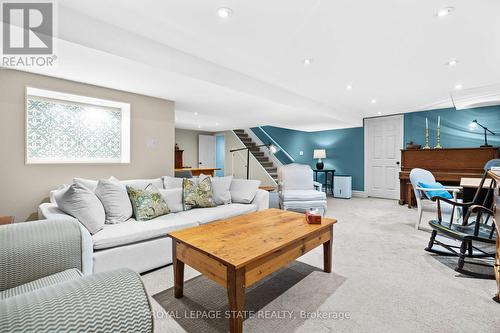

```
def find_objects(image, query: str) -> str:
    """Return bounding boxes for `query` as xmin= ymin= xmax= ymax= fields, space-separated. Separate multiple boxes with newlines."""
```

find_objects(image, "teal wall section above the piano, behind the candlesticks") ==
xmin=404 ymin=106 xmax=500 ymax=148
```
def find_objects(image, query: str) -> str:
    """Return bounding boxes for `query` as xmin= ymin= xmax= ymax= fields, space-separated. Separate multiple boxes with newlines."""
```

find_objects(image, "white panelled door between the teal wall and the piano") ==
xmin=364 ymin=115 xmax=403 ymax=199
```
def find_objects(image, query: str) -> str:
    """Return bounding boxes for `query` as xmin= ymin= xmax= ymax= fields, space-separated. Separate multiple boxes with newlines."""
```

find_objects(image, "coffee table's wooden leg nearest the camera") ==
xmin=227 ymin=267 xmax=245 ymax=333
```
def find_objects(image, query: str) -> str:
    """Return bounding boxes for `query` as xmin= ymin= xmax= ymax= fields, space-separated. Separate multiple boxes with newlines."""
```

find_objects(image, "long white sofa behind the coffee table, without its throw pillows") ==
xmin=38 ymin=178 xmax=269 ymax=274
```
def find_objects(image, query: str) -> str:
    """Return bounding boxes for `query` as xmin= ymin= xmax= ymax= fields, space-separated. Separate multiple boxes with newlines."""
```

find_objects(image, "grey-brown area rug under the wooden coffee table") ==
xmin=153 ymin=261 xmax=345 ymax=333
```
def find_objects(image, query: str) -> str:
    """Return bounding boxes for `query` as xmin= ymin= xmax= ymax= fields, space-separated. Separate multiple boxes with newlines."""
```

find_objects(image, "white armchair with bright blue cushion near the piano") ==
xmin=410 ymin=168 xmax=462 ymax=229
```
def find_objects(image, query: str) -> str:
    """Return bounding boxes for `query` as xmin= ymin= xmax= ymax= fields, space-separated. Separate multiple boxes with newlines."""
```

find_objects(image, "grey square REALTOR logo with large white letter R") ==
xmin=2 ymin=1 xmax=56 ymax=66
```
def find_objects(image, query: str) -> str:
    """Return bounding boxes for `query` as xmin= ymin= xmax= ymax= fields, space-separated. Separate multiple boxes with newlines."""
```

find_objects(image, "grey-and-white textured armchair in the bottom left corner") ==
xmin=0 ymin=220 xmax=153 ymax=333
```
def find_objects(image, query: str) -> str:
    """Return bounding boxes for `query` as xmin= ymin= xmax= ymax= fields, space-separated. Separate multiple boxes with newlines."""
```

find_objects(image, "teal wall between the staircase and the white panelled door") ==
xmin=252 ymin=126 xmax=365 ymax=191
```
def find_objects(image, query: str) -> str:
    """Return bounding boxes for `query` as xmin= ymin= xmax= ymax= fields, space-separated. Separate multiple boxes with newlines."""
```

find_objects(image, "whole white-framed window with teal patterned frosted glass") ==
xmin=26 ymin=87 xmax=130 ymax=164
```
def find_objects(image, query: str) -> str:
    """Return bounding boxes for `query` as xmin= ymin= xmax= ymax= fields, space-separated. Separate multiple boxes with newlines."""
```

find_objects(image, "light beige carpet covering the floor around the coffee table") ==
xmin=143 ymin=198 xmax=500 ymax=332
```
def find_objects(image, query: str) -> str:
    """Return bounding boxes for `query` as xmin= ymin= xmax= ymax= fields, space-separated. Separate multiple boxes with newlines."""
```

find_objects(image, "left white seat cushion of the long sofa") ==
xmin=92 ymin=214 xmax=198 ymax=249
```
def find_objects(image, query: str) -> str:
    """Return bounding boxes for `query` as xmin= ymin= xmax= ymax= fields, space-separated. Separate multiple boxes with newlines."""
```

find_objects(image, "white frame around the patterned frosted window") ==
xmin=24 ymin=87 xmax=130 ymax=164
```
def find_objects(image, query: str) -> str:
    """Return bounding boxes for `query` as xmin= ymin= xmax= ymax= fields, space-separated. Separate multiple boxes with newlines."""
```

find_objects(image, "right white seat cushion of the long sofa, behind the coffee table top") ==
xmin=175 ymin=203 xmax=257 ymax=224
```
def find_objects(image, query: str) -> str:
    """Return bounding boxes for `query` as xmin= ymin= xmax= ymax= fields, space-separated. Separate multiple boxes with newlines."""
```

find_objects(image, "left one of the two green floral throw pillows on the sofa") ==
xmin=127 ymin=184 xmax=170 ymax=221
